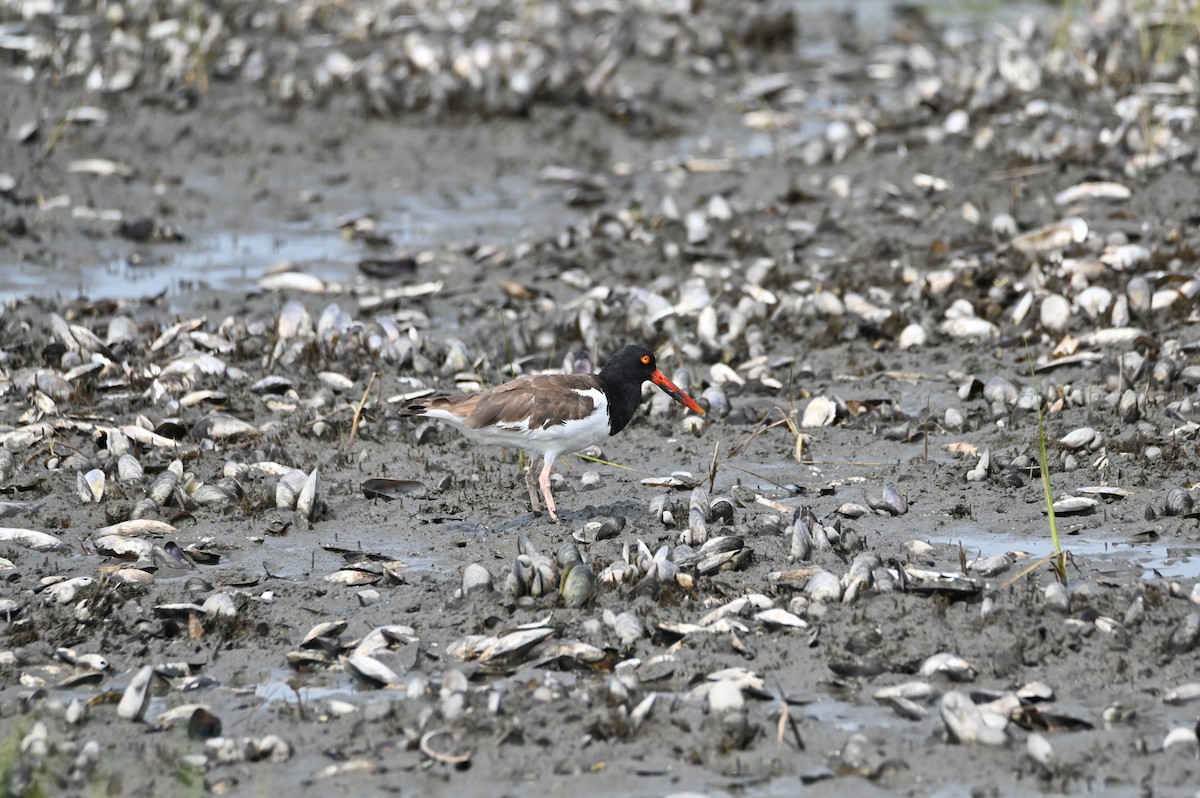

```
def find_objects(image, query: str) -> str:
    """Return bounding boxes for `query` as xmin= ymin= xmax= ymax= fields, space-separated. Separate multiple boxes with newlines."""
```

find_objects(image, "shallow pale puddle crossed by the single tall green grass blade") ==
xmin=930 ymin=522 xmax=1200 ymax=580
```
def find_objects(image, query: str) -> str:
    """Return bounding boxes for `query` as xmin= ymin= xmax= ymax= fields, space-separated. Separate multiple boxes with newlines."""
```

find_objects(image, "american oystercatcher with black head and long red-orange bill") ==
xmin=401 ymin=347 xmax=704 ymax=523
